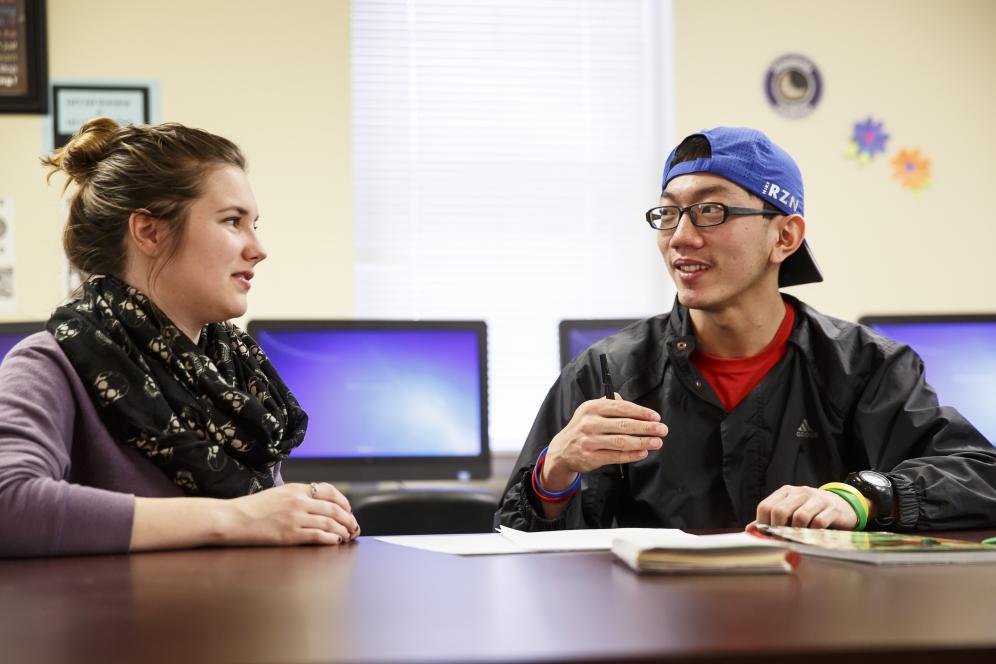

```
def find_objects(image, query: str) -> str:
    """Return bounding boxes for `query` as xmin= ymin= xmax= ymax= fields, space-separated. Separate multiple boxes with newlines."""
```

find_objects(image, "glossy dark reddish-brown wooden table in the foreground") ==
xmin=0 ymin=531 xmax=996 ymax=664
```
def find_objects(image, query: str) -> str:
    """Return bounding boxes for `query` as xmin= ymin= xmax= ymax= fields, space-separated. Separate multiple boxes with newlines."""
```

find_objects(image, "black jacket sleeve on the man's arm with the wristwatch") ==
xmin=854 ymin=346 xmax=996 ymax=530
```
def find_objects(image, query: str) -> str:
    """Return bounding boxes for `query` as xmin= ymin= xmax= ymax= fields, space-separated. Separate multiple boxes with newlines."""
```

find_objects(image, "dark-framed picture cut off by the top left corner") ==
xmin=0 ymin=0 xmax=48 ymax=114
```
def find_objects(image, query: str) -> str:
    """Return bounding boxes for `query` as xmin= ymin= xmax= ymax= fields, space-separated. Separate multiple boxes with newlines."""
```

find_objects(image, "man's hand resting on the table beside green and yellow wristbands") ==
xmin=755 ymin=486 xmax=858 ymax=530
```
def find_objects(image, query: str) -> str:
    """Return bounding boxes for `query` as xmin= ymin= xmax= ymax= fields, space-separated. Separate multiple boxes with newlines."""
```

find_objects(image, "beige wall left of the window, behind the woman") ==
xmin=0 ymin=0 xmax=353 ymax=319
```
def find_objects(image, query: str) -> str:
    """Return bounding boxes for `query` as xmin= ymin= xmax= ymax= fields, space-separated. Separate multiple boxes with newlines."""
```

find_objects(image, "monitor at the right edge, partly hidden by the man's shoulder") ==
xmin=858 ymin=314 xmax=996 ymax=444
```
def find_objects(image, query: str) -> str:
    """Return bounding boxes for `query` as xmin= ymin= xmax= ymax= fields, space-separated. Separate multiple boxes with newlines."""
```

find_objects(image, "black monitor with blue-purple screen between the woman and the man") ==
xmin=248 ymin=320 xmax=491 ymax=482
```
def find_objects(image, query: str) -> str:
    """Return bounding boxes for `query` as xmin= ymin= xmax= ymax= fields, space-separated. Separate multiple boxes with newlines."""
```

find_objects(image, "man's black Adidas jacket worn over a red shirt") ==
xmin=498 ymin=295 xmax=996 ymax=530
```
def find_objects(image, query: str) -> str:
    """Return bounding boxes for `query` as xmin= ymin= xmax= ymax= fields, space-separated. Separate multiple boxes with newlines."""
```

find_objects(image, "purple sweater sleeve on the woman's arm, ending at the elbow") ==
xmin=0 ymin=332 xmax=135 ymax=557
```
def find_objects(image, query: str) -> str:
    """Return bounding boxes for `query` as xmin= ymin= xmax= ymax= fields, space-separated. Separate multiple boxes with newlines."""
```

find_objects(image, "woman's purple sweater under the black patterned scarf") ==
xmin=0 ymin=332 xmax=280 ymax=557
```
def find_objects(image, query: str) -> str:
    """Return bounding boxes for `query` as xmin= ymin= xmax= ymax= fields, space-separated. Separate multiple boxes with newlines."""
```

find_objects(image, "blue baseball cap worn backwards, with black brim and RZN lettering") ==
xmin=661 ymin=127 xmax=823 ymax=287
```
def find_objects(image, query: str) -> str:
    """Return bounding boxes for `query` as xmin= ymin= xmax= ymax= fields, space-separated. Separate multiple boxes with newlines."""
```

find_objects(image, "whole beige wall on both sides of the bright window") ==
xmin=0 ymin=0 xmax=996 ymax=326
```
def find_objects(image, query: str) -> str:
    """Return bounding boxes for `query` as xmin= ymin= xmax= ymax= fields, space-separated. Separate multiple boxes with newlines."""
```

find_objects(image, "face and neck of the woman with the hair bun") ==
xmin=150 ymin=165 xmax=266 ymax=340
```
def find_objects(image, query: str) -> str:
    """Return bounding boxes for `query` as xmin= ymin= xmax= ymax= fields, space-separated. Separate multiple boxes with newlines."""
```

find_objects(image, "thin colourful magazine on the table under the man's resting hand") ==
xmin=757 ymin=525 xmax=996 ymax=565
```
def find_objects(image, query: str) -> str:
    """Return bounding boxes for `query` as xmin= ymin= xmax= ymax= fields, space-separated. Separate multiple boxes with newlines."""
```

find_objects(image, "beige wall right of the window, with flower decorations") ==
xmin=675 ymin=0 xmax=996 ymax=318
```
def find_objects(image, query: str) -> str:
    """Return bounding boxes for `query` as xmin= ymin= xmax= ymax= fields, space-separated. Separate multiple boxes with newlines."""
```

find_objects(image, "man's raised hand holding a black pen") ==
xmin=540 ymin=395 xmax=667 ymax=491
